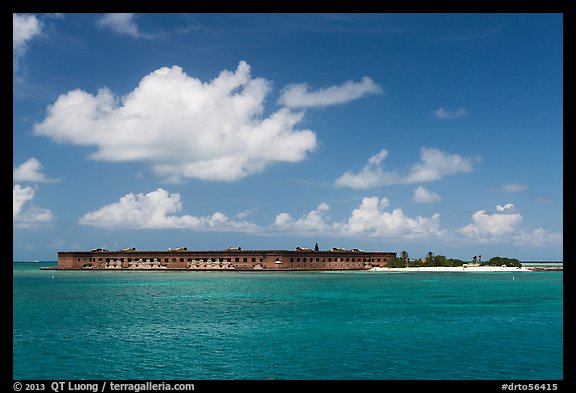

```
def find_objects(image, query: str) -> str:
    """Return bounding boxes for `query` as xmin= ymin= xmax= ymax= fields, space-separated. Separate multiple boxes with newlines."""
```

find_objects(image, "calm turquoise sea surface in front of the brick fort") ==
xmin=13 ymin=263 xmax=563 ymax=380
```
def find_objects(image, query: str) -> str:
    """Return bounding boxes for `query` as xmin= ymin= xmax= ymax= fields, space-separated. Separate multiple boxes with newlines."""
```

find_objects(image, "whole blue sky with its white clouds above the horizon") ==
xmin=13 ymin=13 xmax=563 ymax=261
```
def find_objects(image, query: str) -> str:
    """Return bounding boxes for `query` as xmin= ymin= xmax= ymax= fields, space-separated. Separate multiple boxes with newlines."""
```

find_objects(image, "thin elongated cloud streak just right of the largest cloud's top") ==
xmin=278 ymin=76 xmax=382 ymax=108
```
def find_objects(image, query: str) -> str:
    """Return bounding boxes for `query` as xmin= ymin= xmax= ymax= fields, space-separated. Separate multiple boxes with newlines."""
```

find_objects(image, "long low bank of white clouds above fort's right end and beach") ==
xmin=266 ymin=196 xmax=563 ymax=247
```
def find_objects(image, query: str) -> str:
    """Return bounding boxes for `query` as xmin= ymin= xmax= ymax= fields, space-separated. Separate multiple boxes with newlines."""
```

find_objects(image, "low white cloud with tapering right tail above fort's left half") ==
xmin=78 ymin=188 xmax=258 ymax=232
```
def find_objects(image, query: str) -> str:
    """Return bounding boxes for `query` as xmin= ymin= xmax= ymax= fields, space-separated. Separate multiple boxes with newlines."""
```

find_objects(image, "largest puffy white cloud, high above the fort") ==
xmin=35 ymin=61 xmax=317 ymax=183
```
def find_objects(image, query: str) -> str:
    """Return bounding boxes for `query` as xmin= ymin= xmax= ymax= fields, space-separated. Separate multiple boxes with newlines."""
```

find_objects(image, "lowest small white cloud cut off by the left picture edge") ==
xmin=12 ymin=184 xmax=54 ymax=228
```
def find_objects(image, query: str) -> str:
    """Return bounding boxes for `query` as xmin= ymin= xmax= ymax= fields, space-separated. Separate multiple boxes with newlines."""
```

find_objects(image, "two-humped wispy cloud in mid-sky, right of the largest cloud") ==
xmin=334 ymin=147 xmax=476 ymax=189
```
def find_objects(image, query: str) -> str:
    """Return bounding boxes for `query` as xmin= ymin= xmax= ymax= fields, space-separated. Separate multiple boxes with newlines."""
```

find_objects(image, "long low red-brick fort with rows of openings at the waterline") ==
xmin=58 ymin=247 xmax=396 ymax=271
